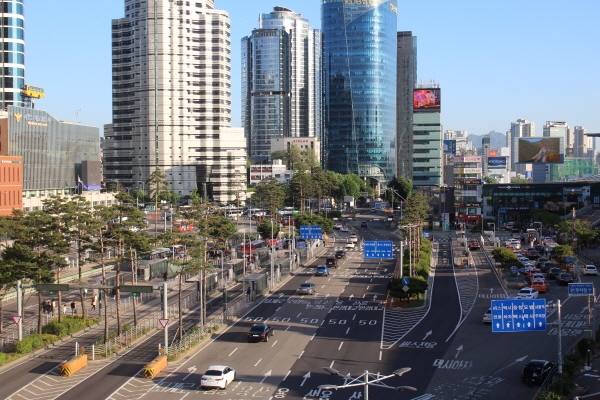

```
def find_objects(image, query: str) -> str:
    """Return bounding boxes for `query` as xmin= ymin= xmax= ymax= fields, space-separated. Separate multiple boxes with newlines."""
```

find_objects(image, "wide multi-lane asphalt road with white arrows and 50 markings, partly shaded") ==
xmin=0 ymin=216 xmax=596 ymax=400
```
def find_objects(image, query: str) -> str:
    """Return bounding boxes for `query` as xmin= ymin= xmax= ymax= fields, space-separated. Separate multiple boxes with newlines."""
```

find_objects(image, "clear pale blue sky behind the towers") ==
xmin=25 ymin=0 xmax=600 ymax=141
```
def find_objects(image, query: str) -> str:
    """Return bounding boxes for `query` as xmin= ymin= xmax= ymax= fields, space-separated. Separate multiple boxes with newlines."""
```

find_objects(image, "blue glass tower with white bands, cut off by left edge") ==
xmin=0 ymin=0 xmax=25 ymax=111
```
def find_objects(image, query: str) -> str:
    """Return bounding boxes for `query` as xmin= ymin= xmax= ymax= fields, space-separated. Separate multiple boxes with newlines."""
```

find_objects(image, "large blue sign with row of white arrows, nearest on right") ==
xmin=492 ymin=299 xmax=546 ymax=332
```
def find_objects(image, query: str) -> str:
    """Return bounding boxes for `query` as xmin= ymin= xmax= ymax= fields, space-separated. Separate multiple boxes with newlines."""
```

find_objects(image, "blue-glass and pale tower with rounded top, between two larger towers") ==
xmin=242 ymin=7 xmax=322 ymax=161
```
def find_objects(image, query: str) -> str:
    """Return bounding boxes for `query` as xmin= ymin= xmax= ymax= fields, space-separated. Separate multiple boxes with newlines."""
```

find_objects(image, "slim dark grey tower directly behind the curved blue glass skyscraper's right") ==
xmin=396 ymin=31 xmax=417 ymax=179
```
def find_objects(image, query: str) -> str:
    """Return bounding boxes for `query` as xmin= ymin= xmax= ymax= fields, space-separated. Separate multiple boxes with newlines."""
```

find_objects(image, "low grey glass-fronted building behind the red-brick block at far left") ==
xmin=0 ymin=106 xmax=100 ymax=198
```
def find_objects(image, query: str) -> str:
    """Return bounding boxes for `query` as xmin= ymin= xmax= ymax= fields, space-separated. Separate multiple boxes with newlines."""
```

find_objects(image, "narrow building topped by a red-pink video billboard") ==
xmin=412 ymin=83 xmax=444 ymax=186
